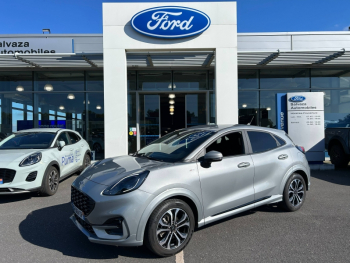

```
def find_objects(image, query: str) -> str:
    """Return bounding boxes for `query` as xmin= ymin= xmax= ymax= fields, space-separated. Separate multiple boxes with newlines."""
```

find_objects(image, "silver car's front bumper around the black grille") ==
xmin=70 ymin=176 xmax=154 ymax=246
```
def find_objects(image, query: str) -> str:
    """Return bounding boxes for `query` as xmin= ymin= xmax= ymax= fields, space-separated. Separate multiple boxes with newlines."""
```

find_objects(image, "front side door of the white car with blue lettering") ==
xmin=56 ymin=132 xmax=74 ymax=177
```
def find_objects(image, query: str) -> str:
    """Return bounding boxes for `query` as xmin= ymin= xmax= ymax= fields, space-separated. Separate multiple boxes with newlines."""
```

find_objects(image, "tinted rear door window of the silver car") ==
xmin=248 ymin=131 xmax=279 ymax=153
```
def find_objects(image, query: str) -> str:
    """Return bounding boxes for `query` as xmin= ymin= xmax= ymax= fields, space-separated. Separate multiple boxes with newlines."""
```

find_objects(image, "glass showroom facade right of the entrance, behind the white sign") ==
xmin=238 ymin=68 xmax=350 ymax=128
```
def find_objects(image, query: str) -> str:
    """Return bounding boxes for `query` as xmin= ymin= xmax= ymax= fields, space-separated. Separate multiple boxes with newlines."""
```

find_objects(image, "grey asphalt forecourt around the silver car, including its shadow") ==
xmin=0 ymin=166 xmax=350 ymax=263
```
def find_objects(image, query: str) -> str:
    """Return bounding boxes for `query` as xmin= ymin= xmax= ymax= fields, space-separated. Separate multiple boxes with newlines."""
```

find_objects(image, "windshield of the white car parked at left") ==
xmin=0 ymin=132 xmax=56 ymax=150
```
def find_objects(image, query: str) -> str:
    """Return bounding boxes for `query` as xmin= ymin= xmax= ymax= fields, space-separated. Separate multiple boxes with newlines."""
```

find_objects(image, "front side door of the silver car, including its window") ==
xmin=197 ymin=132 xmax=254 ymax=218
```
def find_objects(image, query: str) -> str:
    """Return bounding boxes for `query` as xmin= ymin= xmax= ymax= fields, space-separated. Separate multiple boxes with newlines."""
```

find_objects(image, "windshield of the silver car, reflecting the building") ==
xmin=136 ymin=130 xmax=214 ymax=162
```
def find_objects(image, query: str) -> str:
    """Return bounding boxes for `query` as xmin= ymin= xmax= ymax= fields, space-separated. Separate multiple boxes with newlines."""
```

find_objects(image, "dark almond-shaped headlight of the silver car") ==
xmin=103 ymin=171 xmax=149 ymax=195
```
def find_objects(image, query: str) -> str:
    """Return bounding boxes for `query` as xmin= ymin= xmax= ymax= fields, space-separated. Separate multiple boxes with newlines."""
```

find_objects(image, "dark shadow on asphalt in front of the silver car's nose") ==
xmin=19 ymin=203 xmax=155 ymax=259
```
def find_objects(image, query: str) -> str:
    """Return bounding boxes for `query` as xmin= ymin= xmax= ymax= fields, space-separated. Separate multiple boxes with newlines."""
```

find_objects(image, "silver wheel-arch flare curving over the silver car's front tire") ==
xmin=136 ymin=188 xmax=204 ymax=241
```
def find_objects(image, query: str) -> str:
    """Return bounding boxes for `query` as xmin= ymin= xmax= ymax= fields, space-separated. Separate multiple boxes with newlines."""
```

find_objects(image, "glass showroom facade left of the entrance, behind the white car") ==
xmin=0 ymin=71 xmax=104 ymax=159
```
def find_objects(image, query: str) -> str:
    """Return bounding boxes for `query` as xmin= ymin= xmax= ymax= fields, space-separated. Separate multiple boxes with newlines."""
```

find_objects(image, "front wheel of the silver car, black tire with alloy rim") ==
xmin=144 ymin=199 xmax=195 ymax=257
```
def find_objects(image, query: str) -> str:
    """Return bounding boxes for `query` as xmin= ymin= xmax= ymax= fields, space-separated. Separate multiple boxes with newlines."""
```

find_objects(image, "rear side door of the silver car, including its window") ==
xmin=247 ymin=131 xmax=293 ymax=200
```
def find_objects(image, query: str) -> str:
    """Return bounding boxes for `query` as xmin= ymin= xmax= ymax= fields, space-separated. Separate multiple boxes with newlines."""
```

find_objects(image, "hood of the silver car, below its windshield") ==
xmin=80 ymin=155 xmax=171 ymax=186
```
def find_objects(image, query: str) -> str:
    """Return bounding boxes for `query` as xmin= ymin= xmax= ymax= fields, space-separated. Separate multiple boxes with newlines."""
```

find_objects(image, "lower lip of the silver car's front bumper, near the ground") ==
xmin=70 ymin=214 xmax=143 ymax=247
